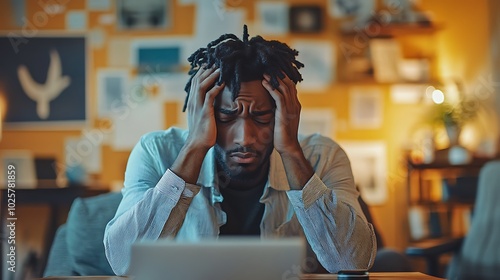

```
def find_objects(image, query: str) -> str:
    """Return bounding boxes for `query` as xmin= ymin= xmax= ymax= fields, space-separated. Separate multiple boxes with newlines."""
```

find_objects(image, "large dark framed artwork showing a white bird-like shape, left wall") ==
xmin=0 ymin=35 xmax=87 ymax=128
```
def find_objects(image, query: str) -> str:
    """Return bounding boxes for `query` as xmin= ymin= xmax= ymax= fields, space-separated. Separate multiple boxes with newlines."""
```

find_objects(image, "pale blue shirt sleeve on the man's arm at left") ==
xmin=103 ymin=135 xmax=199 ymax=275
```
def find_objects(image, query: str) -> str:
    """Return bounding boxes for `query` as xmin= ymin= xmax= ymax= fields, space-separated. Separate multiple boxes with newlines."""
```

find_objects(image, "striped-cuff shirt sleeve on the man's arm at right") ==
xmin=287 ymin=144 xmax=377 ymax=273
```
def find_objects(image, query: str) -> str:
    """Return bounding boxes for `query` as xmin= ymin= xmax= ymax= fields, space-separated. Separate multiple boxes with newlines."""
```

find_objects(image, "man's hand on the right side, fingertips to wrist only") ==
xmin=262 ymin=75 xmax=301 ymax=154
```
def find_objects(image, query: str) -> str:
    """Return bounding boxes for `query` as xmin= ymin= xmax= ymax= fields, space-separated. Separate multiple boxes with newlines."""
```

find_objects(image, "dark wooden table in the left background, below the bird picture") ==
xmin=0 ymin=186 xmax=108 ymax=276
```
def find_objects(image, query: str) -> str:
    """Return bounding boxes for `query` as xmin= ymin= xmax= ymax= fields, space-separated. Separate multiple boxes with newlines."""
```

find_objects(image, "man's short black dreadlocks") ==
xmin=182 ymin=25 xmax=304 ymax=111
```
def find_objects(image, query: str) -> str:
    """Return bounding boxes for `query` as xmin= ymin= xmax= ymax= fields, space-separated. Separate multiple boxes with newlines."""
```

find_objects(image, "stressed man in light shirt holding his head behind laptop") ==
xmin=104 ymin=26 xmax=376 ymax=275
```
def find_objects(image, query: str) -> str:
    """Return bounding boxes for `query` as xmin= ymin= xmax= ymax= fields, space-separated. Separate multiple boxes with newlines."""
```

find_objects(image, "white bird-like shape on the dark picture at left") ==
xmin=17 ymin=50 xmax=71 ymax=119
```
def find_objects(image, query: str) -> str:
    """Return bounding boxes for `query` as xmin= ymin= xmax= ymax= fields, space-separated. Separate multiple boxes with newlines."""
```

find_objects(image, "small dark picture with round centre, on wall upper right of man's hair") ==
xmin=289 ymin=6 xmax=323 ymax=33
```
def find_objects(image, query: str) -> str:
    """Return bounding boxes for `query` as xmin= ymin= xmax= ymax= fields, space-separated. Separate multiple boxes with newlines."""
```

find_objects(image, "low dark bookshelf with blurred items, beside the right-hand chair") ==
xmin=407 ymin=154 xmax=491 ymax=243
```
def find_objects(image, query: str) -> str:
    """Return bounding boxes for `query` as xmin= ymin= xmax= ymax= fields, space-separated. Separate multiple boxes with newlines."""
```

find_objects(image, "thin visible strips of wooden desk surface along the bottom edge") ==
xmin=43 ymin=272 xmax=442 ymax=280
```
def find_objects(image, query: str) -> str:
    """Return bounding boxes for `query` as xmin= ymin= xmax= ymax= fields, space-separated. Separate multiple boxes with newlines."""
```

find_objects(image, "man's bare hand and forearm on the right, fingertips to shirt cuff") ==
xmin=262 ymin=75 xmax=314 ymax=190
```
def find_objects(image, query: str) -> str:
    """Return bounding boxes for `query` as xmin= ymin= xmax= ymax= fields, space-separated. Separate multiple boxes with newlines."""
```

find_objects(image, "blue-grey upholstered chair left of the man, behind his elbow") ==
xmin=43 ymin=193 xmax=122 ymax=277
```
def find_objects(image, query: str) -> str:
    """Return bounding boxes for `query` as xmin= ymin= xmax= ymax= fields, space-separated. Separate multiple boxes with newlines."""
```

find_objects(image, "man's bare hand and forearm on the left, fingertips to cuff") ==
xmin=170 ymin=67 xmax=224 ymax=184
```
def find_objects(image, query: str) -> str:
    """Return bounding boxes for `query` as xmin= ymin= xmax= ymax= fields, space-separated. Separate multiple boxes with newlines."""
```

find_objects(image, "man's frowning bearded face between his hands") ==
xmin=215 ymin=80 xmax=275 ymax=181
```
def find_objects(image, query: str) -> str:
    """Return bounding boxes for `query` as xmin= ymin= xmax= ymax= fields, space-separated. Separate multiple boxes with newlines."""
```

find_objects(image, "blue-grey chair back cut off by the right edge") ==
xmin=447 ymin=160 xmax=500 ymax=279
